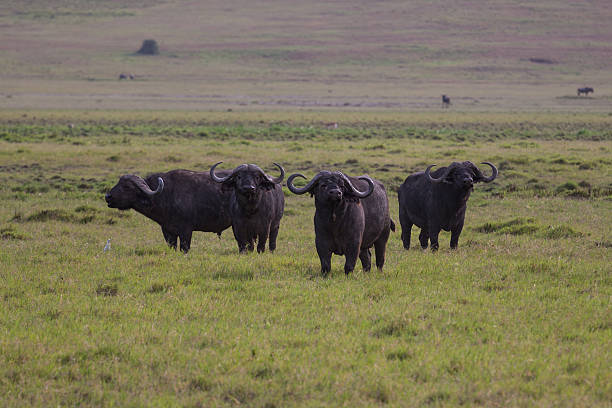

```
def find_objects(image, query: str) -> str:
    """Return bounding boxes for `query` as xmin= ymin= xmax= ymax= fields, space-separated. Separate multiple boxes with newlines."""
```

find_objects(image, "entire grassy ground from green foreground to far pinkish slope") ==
xmin=0 ymin=0 xmax=612 ymax=408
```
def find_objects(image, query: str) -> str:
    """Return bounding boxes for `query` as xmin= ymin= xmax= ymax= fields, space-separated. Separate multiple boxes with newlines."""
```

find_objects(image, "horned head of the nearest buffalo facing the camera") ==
xmin=287 ymin=170 xmax=374 ymax=203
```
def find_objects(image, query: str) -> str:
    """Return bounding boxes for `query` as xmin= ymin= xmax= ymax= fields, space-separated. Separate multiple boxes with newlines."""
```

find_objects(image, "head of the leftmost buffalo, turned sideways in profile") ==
xmin=104 ymin=174 xmax=164 ymax=210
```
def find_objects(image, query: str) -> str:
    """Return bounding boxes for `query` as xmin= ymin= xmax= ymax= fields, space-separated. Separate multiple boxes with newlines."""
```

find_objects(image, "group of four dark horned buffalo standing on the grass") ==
xmin=105 ymin=161 xmax=498 ymax=275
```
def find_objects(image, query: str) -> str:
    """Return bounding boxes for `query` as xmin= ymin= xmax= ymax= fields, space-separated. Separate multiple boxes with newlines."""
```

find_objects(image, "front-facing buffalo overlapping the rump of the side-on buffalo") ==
xmin=210 ymin=162 xmax=285 ymax=253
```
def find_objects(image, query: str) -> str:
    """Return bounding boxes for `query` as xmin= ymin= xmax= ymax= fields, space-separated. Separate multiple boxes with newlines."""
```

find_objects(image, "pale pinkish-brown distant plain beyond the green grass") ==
xmin=0 ymin=0 xmax=612 ymax=112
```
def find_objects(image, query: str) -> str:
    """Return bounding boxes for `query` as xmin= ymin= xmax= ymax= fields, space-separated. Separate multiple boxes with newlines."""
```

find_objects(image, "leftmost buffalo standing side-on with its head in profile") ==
xmin=105 ymin=170 xmax=232 ymax=253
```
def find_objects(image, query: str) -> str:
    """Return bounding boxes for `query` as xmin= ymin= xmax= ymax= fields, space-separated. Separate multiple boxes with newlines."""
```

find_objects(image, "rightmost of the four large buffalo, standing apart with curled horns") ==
xmin=398 ymin=161 xmax=498 ymax=251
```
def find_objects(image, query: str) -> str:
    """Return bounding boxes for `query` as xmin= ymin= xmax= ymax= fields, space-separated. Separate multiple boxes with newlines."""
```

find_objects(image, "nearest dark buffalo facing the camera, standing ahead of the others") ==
xmin=287 ymin=171 xmax=395 ymax=275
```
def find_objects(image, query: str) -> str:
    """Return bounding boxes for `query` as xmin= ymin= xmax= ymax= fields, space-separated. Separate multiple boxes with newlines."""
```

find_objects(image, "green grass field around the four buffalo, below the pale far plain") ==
xmin=0 ymin=111 xmax=612 ymax=407
